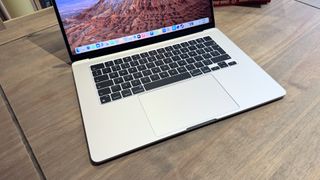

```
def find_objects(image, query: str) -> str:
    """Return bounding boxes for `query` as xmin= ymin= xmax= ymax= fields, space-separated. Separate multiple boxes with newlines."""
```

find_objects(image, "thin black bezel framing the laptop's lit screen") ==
xmin=52 ymin=0 xmax=215 ymax=62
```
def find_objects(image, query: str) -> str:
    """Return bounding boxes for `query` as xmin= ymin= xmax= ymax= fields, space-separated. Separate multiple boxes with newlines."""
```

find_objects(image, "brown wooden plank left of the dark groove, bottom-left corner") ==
xmin=0 ymin=92 xmax=39 ymax=180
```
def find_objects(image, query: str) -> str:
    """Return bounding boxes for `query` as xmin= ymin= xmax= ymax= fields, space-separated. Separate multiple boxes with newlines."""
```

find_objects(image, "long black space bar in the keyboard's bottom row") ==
xmin=144 ymin=72 xmax=191 ymax=91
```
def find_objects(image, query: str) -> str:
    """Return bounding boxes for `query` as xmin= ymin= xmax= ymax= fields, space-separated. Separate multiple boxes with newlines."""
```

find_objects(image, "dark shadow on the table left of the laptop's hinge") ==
xmin=27 ymin=25 xmax=71 ymax=65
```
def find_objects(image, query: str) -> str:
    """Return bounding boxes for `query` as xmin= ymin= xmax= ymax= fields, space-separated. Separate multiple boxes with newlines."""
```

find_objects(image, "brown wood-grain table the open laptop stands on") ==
xmin=0 ymin=0 xmax=320 ymax=180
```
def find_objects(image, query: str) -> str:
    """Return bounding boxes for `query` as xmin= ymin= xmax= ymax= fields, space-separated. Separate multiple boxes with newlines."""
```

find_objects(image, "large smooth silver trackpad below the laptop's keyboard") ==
xmin=139 ymin=75 xmax=239 ymax=136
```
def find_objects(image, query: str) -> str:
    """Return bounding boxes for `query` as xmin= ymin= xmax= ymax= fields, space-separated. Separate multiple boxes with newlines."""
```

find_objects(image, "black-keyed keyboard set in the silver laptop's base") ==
xmin=90 ymin=36 xmax=237 ymax=104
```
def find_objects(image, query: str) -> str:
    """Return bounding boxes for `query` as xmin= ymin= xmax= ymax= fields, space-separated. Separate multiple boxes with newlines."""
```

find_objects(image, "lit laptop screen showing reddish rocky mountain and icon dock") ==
xmin=56 ymin=0 xmax=213 ymax=55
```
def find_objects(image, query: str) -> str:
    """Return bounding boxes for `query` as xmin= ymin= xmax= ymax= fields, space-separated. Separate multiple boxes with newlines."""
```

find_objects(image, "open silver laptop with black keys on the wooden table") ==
xmin=53 ymin=0 xmax=286 ymax=165
